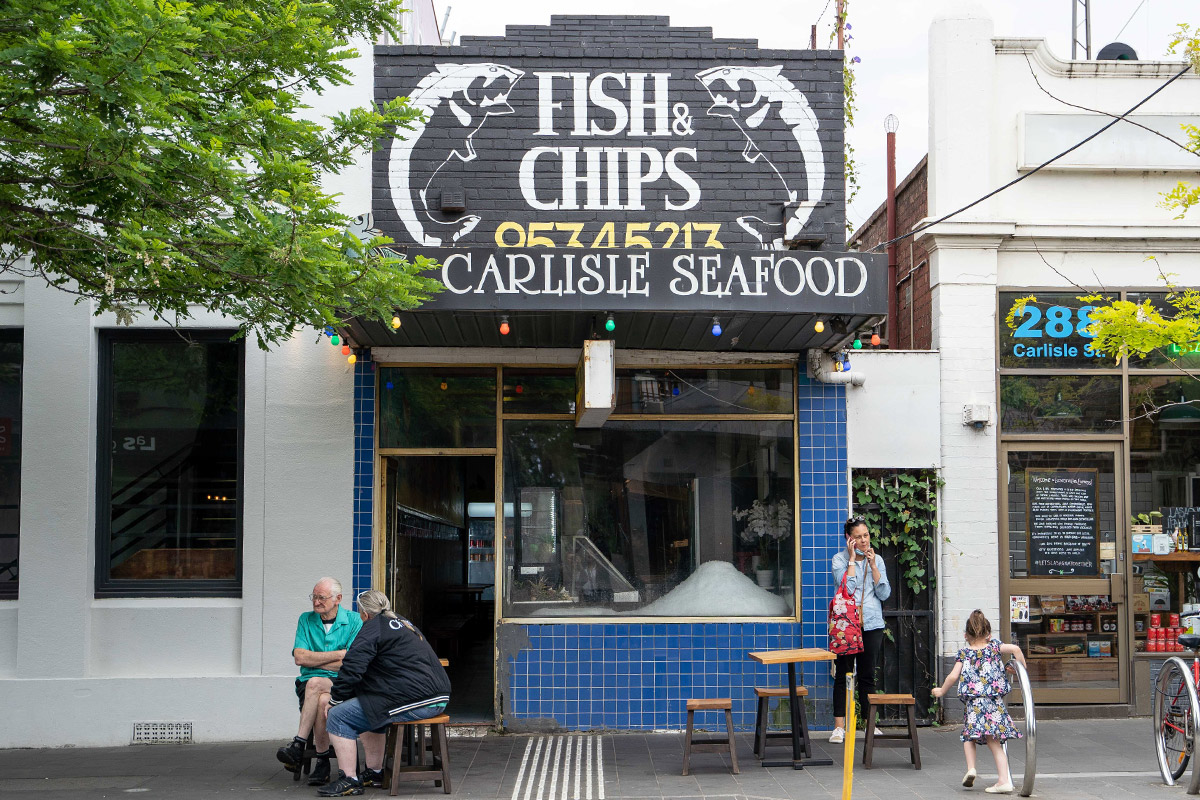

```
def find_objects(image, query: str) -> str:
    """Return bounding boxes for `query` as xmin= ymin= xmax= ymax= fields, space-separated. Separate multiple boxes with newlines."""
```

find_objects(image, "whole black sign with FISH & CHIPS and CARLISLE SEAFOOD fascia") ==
xmin=372 ymin=17 xmax=887 ymax=313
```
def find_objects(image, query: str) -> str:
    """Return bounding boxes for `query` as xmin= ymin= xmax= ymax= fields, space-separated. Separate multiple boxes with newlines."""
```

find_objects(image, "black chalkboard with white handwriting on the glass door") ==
xmin=1025 ymin=469 xmax=1099 ymax=577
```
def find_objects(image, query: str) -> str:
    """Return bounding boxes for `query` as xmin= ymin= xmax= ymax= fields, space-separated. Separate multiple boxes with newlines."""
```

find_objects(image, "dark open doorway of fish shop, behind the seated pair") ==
xmin=378 ymin=455 xmax=496 ymax=724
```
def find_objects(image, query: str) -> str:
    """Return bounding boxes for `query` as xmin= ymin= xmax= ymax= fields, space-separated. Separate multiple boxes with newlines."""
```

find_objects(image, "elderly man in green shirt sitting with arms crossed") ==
xmin=276 ymin=578 xmax=362 ymax=786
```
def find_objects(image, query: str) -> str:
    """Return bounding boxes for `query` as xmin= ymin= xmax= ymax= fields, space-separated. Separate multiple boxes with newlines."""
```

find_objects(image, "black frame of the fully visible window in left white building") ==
xmin=95 ymin=329 xmax=246 ymax=599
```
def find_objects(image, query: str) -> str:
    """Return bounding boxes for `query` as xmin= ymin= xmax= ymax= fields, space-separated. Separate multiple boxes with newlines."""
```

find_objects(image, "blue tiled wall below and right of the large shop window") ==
xmin=500 ymin=376 xmax=850 ymax=730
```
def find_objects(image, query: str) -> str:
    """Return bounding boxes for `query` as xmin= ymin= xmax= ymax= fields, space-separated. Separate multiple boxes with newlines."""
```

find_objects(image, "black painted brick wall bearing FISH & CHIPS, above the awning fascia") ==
xmin=372 ymin=16 xmax=845 ymax=251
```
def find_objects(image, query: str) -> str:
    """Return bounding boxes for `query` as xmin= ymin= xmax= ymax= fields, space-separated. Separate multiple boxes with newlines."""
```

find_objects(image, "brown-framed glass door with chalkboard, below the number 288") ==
xmin=1000 ymin=441 xmax=1132 ymax=703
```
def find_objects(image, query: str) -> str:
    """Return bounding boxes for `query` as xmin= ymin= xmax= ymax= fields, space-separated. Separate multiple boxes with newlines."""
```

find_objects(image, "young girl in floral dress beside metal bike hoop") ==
xmin=934 ymin=608 xmax=1025 ymax=794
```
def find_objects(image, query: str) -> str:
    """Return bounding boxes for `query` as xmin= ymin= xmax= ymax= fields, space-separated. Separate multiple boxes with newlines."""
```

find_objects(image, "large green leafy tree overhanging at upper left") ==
xmin=0 ymin=0 xmax=439 ymax=347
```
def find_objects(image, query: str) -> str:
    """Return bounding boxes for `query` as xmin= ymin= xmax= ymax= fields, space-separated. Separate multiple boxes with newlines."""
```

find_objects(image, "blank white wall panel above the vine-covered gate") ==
xmin=846 ymin=350 xmax=942 ymax=469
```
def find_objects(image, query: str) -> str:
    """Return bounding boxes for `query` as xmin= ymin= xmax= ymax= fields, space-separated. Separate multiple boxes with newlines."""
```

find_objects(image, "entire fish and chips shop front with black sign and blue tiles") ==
xmin=338 ymin=17 xmax=887 ymax=729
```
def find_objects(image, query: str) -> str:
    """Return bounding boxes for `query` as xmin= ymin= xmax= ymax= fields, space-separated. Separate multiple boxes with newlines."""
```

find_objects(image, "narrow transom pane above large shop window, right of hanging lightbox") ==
xmin=614 ymin=368 xmax=793 ymax=415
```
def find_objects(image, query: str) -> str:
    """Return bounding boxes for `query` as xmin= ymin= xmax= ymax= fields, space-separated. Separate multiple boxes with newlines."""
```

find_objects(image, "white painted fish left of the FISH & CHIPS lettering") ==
xmin=390 ymin=61 xmax=524 ymax=247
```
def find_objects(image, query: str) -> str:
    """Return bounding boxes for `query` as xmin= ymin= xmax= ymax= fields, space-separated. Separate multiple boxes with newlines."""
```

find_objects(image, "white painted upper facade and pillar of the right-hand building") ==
xmin=920 ymin=4 xmax=1200 ymax=655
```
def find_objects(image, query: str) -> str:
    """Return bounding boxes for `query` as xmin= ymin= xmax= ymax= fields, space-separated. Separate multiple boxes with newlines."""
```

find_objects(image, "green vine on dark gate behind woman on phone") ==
xmin=853 ymin=470 xmax=943 ymax=594
